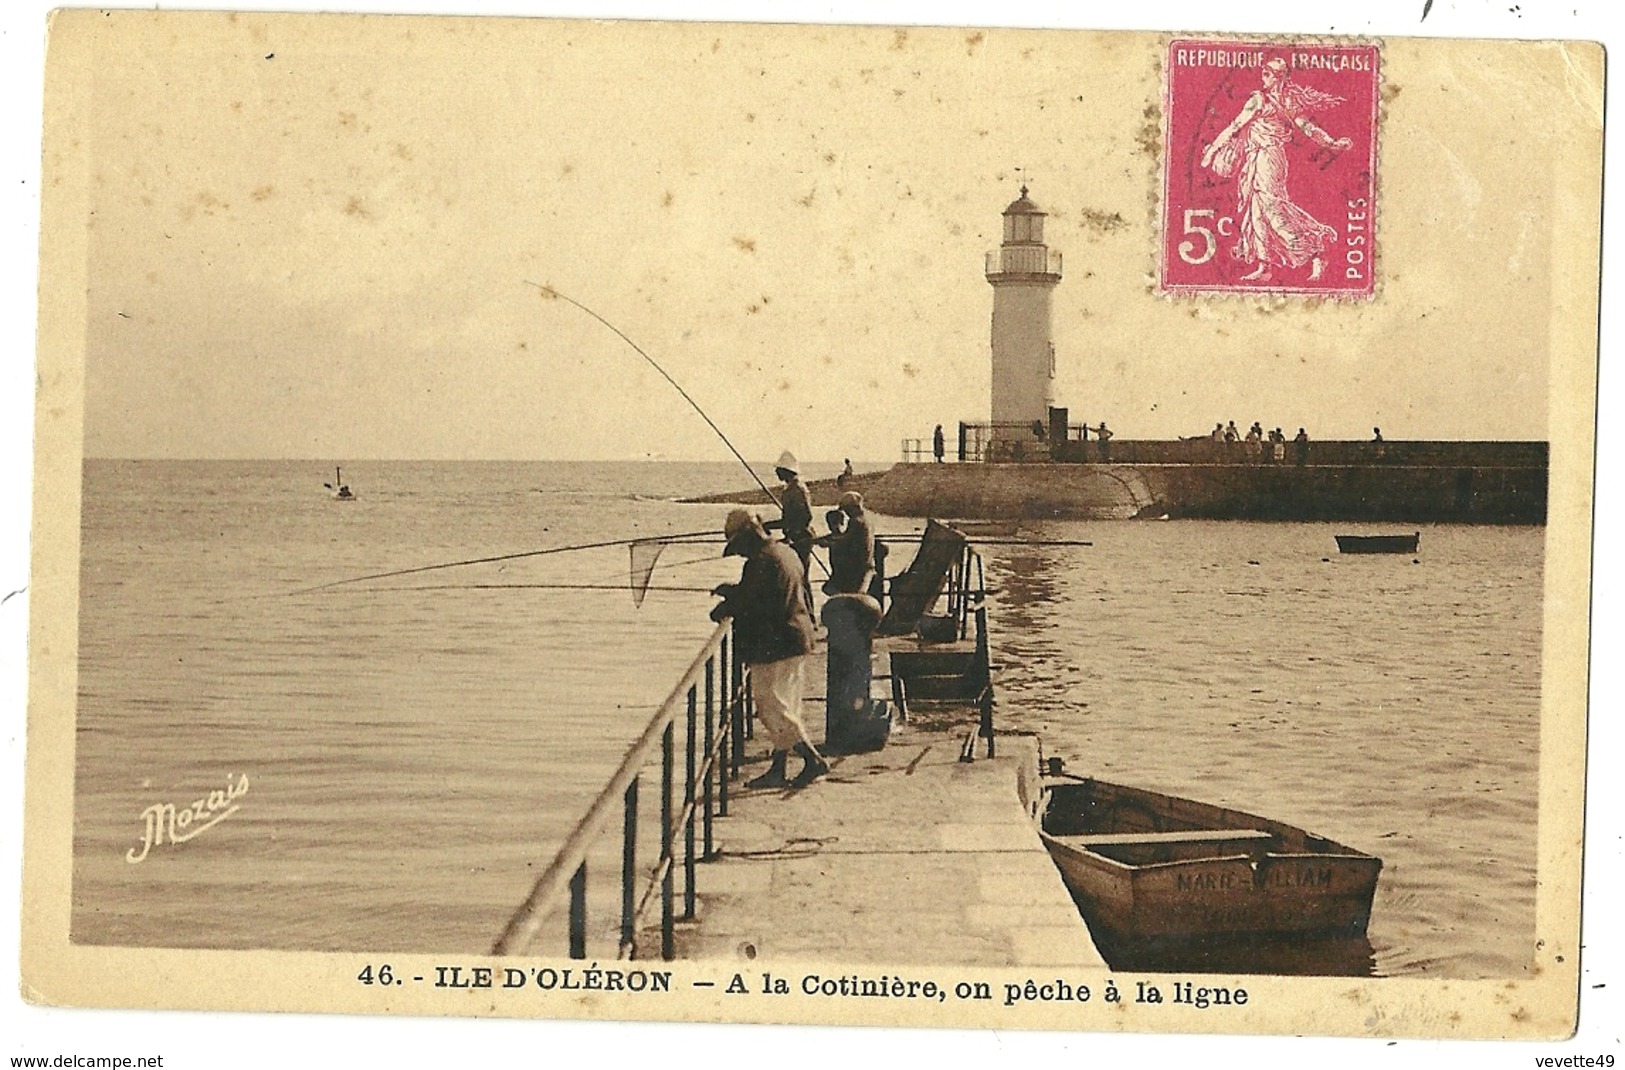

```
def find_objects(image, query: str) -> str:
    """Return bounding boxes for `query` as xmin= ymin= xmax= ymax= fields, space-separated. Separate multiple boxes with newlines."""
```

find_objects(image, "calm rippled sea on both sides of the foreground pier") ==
xmin=73 ymin=460 xmax=1544 ymax=977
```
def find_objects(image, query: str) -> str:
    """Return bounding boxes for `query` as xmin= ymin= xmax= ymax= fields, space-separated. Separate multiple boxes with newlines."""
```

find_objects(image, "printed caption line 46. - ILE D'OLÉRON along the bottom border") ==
xmin=356 ymin=963 xmax=1250 ymax=1010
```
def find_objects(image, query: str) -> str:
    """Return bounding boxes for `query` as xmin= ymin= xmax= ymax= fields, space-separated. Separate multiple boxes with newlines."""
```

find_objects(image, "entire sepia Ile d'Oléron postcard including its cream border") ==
xmin=21 ymin=10 xmax=1604 ymax=1039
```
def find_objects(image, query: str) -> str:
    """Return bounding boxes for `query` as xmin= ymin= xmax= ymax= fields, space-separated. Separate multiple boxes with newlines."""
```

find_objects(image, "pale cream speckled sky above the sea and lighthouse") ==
xmin=69 ymin=1 xmax=1594 ymax=460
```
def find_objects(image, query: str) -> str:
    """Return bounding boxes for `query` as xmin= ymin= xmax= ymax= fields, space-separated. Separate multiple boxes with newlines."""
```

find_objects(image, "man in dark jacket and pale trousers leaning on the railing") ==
xmin=710 ymin=509 xmax=829 ymax=787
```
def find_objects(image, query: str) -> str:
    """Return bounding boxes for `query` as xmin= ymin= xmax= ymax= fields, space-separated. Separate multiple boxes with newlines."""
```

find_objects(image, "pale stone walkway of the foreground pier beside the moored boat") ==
xmin=678 ymin=640 xmax=1103 ymax=968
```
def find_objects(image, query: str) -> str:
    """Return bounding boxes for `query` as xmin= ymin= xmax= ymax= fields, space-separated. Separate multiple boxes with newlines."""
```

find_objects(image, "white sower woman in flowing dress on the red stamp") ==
xmin=1203 ymin=55 xmax=1354 ymax=281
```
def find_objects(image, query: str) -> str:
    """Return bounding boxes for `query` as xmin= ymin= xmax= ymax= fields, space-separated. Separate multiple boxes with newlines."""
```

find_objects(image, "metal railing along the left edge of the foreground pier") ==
xmin=492 ymin=621 xmax=752 ymax=961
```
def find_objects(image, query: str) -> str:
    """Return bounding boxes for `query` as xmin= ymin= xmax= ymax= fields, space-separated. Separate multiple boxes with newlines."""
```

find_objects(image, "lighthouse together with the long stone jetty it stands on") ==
xmin=696 ymin=185 xmax=1547 ymax=524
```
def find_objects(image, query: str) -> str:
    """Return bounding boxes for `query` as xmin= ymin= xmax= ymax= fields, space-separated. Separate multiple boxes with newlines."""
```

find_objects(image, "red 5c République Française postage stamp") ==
xmin=1160 ymin=41 xmax=1378 ymax=298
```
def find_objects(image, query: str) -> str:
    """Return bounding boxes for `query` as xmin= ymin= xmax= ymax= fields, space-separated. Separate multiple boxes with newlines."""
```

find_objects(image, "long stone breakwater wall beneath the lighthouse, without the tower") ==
xmin=685 ymin=441 xmax=1547 ymax=524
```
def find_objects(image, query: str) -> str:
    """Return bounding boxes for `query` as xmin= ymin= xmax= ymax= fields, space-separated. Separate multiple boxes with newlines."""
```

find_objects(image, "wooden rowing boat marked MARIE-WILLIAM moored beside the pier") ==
xmin=1040 ymin=763 xmax=1383 ymax=945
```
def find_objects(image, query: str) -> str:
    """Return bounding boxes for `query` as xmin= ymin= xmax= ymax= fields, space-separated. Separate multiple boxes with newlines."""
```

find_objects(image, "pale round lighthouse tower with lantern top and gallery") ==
xmin=986 ymin=185 xmax=1061 ymax=442
